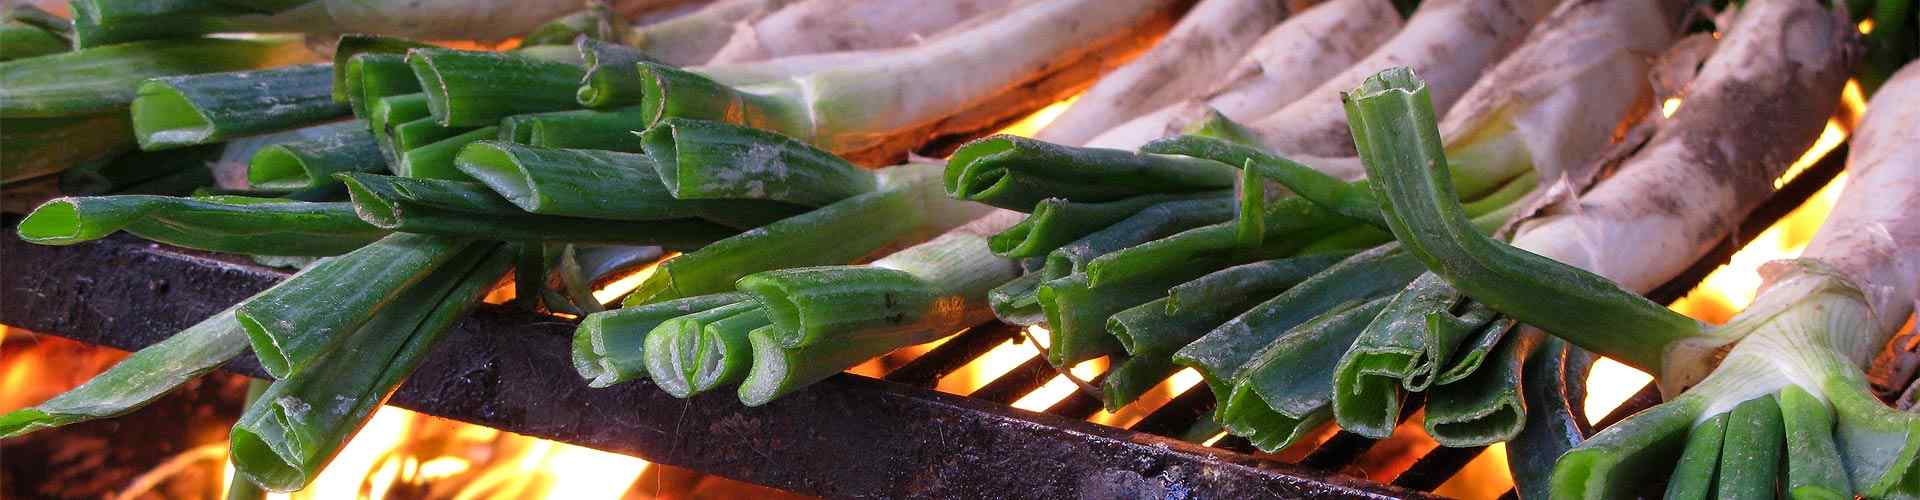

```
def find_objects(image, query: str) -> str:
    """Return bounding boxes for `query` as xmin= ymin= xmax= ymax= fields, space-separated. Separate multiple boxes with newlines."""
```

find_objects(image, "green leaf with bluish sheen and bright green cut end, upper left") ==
xmin=132 ymin=63 xmax=349 ymax=150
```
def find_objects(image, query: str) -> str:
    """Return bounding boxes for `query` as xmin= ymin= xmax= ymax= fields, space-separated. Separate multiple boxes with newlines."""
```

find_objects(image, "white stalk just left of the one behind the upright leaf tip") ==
xmin=1090 ymin=0 xmax=1402 ymax=150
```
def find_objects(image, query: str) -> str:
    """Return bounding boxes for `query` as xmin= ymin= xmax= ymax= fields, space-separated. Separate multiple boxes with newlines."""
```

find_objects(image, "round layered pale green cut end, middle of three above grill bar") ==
xmin=645 ymin=300 xmax=772 ymax=398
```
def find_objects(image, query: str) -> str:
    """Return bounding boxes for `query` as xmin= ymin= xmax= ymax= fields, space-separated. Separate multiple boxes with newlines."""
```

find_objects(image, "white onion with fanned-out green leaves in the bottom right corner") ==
xmin=1553 ymin=59 xmax=1920 ymax=498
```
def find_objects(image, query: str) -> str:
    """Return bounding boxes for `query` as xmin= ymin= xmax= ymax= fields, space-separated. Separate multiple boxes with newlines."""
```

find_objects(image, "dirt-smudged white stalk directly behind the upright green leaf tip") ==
xmin=1248 ymin=0 xmax=1559 ymax=158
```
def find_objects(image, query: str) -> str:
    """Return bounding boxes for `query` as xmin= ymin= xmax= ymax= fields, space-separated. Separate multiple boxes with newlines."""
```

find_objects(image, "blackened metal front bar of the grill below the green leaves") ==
xmin=0 ymin=229 xmax=1421 ymax=498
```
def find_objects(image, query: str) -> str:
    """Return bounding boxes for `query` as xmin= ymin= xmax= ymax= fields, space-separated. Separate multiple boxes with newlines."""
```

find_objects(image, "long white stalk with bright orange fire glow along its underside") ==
xmin=643 ymin=0 xmax=1179 ymax=158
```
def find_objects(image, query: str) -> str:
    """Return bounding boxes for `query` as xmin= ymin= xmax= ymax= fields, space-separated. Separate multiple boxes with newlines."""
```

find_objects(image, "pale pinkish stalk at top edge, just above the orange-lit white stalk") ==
xmin=707 ymin=0 xmax=1014 ymax=65
